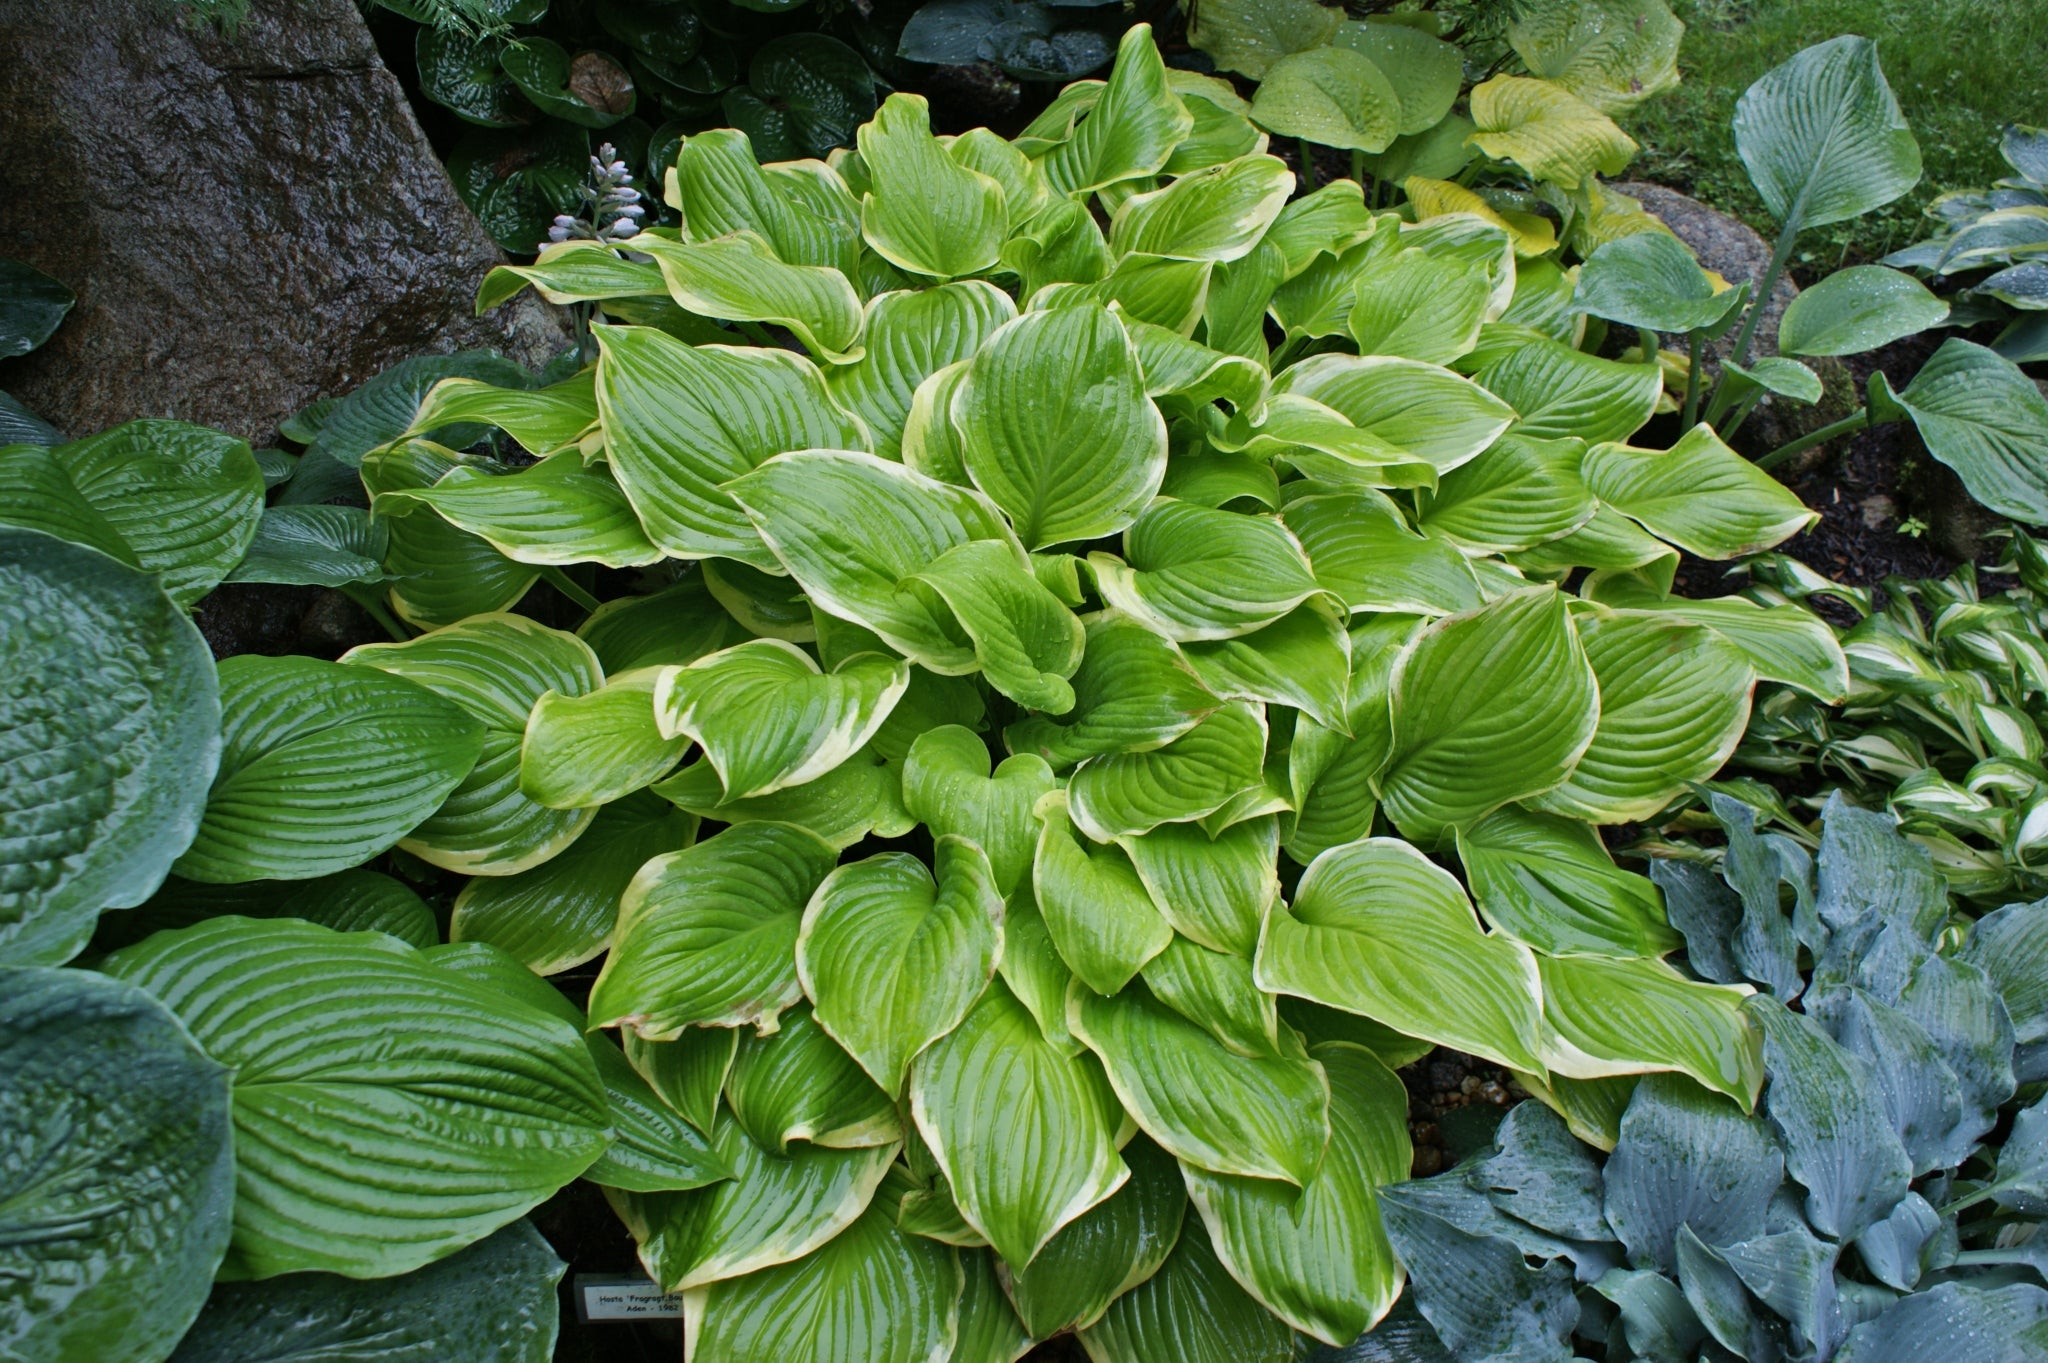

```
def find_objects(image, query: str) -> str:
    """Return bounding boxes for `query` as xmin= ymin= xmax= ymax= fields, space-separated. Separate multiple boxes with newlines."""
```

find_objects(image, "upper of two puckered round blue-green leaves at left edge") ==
xmin=0 ymin=528 xmax=221 ymax=966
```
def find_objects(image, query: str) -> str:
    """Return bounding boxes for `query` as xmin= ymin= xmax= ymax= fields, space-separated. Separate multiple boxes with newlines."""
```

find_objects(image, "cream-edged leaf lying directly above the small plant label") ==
xmin=606 ymin=1113 xmax=897 ymax=1291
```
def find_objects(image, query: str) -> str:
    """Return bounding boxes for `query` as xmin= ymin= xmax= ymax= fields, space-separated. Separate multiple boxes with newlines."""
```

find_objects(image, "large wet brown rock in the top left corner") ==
xmin=0 ymin=0 xmax=569 ymax=442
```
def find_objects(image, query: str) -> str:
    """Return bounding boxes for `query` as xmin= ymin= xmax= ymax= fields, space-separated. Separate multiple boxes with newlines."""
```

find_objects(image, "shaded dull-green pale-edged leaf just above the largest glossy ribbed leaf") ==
xmin=449 ymin=792 xmax=696 ymax=974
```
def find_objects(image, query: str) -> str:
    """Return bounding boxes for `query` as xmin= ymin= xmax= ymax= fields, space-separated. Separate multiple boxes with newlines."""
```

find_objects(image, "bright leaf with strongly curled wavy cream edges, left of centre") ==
xmin=653 ymin=639 xmax=909 ymax=800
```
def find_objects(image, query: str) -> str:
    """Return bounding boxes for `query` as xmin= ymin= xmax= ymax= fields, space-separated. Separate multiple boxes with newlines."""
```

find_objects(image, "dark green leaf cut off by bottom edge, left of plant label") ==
xmin=170 ymin=1219 xmax=563 ymax=1363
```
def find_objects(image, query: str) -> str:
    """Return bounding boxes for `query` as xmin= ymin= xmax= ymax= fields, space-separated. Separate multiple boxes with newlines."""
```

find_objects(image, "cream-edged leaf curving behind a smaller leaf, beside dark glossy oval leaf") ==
xmin=342 ymin=614 xmax=604 ymax=863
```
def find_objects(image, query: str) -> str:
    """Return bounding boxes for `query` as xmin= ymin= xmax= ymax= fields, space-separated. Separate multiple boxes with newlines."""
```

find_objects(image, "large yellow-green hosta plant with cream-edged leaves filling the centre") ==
xmin=372 ymin=27 xmax=1845 ymax=1363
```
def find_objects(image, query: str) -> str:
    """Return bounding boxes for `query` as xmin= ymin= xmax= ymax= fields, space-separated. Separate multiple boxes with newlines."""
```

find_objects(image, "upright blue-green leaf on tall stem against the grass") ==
xmin=1735 ymin=37 xmax=1921 ymax=229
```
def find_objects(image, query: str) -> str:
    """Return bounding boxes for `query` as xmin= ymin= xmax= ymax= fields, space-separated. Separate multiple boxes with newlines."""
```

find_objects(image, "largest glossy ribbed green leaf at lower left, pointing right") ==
xmin=104 ymin=917 xmax=610 ymax=1277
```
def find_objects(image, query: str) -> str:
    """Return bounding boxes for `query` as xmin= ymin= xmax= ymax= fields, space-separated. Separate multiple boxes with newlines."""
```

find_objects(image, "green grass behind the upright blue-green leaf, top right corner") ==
xmin=1622 ymin=0 xmax=2048 ymax=282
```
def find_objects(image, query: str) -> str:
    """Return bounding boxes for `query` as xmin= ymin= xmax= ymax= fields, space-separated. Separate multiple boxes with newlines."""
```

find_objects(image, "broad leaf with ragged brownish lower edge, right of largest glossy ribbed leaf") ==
xmin=590 ymin=823 xmax=838 ymax=1042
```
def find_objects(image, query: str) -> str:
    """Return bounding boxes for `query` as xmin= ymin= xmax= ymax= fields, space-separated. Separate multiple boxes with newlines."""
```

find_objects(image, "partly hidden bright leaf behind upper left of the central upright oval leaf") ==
xmin=825 ymin=280 xmax=1018 ymax=458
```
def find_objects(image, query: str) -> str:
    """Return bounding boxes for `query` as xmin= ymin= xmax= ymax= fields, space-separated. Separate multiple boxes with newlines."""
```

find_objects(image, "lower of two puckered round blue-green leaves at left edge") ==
xmin=0 ymin=968 xmax=236 ymax=1363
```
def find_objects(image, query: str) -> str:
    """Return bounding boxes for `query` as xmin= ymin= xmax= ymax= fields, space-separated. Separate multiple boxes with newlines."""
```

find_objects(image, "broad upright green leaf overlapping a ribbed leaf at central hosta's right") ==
xmin=1378 ymin=587 xmax=1599 ymax=839
